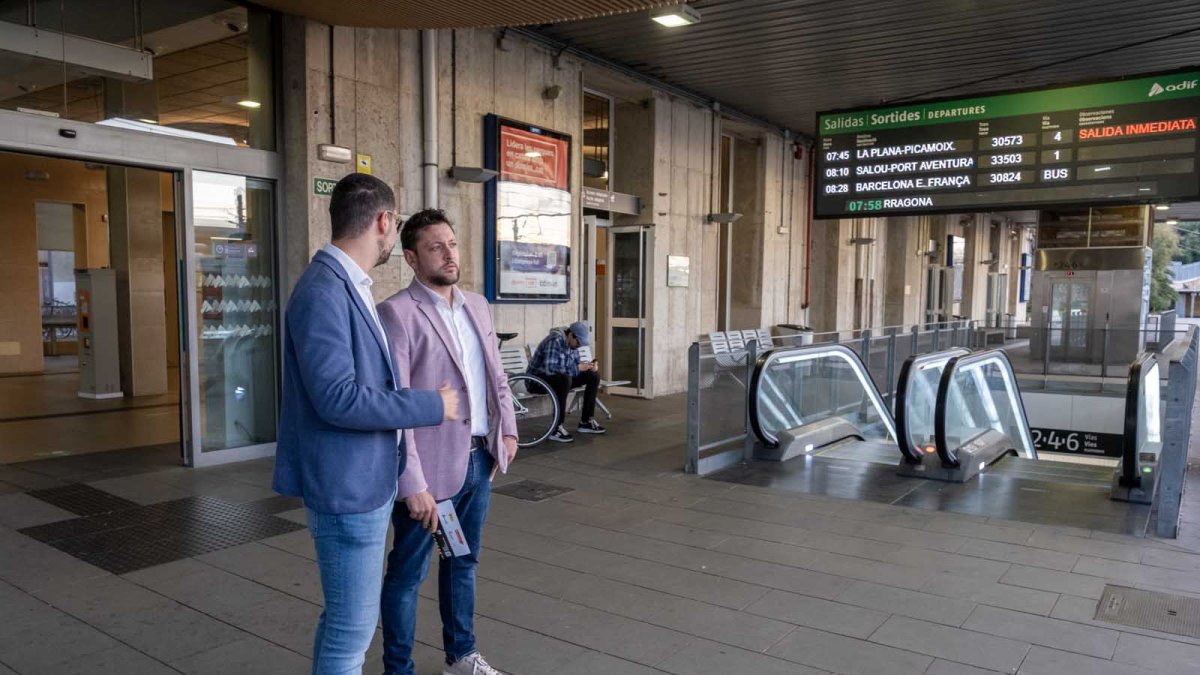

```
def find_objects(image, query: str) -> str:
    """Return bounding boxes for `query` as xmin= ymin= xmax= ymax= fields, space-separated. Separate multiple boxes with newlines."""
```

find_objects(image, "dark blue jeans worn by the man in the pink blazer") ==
xmin=383 ymin=448 xmax=496 ymax=675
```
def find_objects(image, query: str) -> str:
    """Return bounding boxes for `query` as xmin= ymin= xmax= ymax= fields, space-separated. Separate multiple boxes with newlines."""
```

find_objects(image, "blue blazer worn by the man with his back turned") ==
xmin=274 ymin=251 xmax=443 ymax=513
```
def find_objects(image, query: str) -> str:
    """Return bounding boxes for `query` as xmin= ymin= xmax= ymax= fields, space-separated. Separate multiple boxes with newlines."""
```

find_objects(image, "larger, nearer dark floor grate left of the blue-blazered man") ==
xmin=20 ymin=485 xmax=305 ymax=574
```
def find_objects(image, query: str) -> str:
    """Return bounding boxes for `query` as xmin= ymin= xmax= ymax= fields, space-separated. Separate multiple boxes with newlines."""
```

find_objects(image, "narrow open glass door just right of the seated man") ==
xmin=605 ymin=225 xmax=654 ymax=396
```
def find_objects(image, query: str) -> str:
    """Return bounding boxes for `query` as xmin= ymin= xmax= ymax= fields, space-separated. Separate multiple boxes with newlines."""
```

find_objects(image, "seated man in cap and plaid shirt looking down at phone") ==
xmin=529 ymin=321 xmax=605 ymax=443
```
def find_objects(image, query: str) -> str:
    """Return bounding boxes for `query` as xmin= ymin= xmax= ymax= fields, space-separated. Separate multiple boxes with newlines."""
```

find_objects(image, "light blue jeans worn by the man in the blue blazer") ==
xmin=308 ymin=487 xmax=395 ymax=675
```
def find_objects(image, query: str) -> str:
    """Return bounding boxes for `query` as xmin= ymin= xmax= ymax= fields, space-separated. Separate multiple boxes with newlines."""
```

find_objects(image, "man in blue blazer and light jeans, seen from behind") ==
xmin=274 ymin=173 xmax=458 ymax=675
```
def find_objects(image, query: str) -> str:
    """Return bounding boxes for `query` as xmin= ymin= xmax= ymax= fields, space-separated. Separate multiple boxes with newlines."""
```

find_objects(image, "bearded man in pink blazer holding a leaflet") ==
xmin=379 ymin=209 xmax=517 ymax=675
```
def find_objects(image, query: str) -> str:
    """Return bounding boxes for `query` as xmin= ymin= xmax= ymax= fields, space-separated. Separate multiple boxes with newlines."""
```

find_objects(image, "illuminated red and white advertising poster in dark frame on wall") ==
xmin=484 ymin=114 xmax=575 ymax=303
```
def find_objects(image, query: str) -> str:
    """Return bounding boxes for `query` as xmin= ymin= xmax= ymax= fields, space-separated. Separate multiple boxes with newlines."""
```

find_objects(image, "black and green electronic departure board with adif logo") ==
xmin=814 ymin=71 xmax=1200 ymax=219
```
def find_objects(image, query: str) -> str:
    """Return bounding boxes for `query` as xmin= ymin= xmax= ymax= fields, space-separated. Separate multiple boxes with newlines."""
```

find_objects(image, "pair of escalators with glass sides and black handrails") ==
xmin=749 ymin=345 xmax=1162 ymax=494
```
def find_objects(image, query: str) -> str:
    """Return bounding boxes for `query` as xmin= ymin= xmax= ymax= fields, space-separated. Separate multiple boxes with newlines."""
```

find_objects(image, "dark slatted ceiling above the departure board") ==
xmin=538 ymin=0 xmax=1200 ymax=136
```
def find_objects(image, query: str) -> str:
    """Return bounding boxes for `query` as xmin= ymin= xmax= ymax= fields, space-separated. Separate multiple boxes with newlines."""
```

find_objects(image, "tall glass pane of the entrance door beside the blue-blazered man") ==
xmin=192 ymin=171 xmax=278 ymax=452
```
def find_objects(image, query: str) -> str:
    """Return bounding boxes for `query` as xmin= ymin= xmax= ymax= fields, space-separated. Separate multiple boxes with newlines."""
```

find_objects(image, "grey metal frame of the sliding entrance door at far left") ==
xmin=0 ymin=110 xmax=288 ymax=467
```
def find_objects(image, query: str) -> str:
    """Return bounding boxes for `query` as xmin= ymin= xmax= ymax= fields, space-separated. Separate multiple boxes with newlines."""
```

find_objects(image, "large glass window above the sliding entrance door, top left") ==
xmin=0 ymin=0 xmax=275 ymax=150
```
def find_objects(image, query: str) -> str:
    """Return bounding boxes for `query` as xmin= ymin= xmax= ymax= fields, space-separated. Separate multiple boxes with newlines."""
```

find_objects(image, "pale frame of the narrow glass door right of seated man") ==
xmin=604 ymin=225 xmax=655 ymax=399
